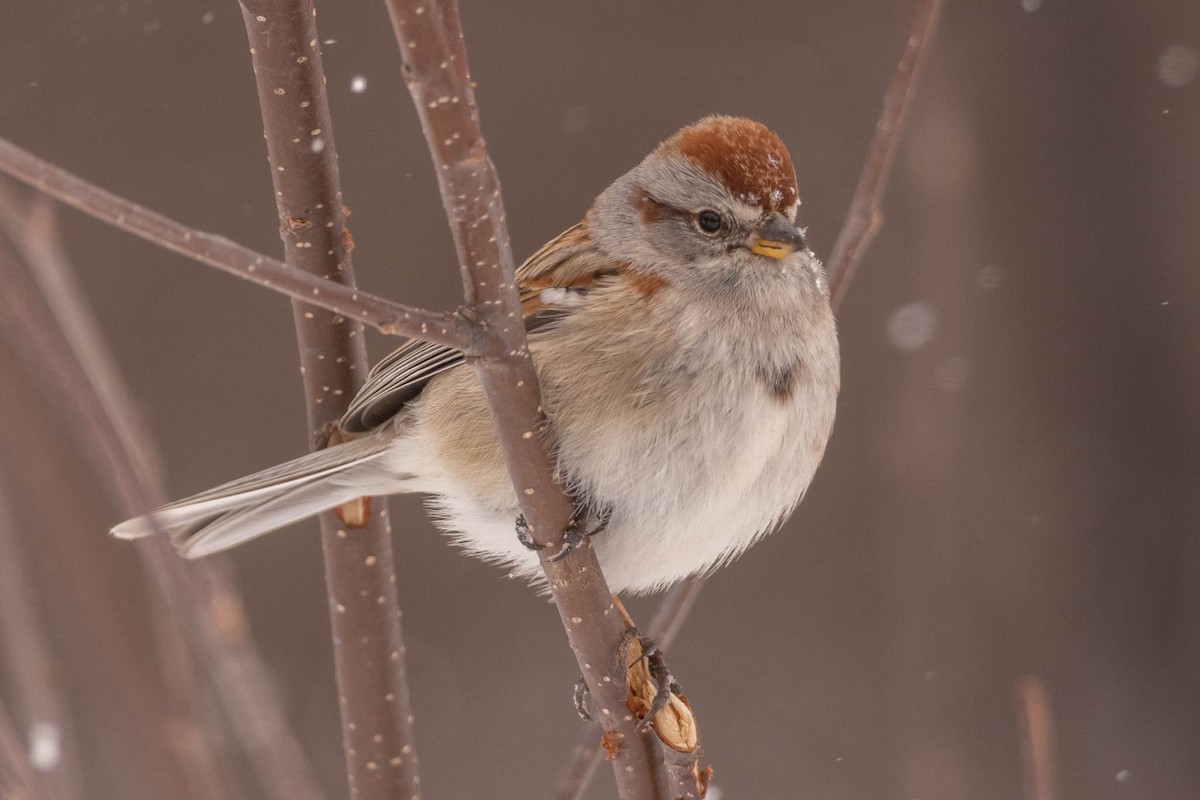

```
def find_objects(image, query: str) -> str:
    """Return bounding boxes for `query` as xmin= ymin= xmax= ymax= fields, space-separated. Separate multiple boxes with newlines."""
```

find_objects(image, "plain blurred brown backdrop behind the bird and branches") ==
xmin=0 ymin=0 xmax=1200 ymax=800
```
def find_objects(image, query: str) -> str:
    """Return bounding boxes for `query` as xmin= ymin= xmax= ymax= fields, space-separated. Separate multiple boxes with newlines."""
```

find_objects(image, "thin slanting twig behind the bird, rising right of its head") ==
xmin=552 ymin=0 xmax=943 ymax=800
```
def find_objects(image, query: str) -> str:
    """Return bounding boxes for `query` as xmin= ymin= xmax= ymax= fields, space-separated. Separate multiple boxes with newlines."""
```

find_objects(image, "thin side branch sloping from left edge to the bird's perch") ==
xmin=0 ymin=132 xmax=479 ymax=354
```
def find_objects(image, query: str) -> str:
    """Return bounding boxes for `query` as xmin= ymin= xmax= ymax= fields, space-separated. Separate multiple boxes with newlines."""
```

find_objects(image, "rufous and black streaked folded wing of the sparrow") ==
xmin=341 ymin=222 xmax=619 ymax=433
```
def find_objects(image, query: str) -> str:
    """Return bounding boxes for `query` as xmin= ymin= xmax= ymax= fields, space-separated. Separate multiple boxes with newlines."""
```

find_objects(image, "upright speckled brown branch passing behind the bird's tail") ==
xmin=241 ymin=0 xmax=422 ymax=800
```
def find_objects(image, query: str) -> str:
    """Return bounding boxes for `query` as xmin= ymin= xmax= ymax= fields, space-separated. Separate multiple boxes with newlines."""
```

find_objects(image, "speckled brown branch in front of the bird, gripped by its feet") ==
xmin=388 ymin=0 xmax=658 ymax=800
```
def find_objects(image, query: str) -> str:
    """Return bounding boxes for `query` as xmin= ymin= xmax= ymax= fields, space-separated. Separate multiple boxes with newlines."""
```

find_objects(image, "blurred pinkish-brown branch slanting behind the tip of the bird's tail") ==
xmin=0 ymin=181 xmax=322 ymax=800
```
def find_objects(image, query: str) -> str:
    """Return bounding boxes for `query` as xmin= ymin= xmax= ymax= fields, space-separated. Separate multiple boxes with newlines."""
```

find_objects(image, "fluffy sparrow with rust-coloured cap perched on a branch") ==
xmin=112 ymin=116 xmax=840 ymax=594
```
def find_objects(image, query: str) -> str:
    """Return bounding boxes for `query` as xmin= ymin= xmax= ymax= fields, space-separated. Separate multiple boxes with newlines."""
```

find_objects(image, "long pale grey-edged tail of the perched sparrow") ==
xmin=112 ymin=432 xmax=401 ymax=558
